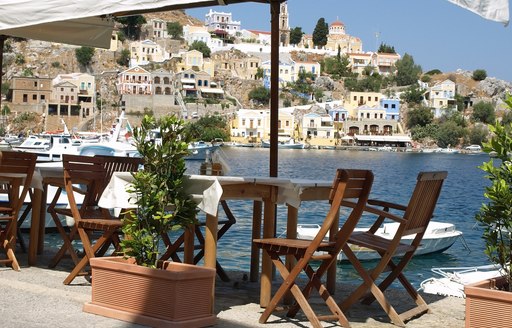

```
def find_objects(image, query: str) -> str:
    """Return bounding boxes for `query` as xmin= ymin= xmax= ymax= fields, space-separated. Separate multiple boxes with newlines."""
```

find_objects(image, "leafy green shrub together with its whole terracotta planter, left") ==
xmin=84 ymin=116 xmax=215 ymax=327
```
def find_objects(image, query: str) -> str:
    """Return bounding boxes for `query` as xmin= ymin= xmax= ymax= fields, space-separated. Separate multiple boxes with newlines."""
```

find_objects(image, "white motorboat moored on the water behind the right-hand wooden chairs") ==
xmin=297 ymin=221 xmax=462 ymax=261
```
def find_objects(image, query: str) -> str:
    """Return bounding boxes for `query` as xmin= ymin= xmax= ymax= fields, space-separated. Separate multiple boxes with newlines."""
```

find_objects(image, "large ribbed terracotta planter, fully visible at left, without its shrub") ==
xmin=83 ymin=257 xmax=216 ymax=328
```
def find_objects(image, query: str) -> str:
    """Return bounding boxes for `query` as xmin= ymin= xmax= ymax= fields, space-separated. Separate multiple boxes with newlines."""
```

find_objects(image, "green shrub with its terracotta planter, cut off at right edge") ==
xmin=464 ymin=95 xmax=512 ymax=327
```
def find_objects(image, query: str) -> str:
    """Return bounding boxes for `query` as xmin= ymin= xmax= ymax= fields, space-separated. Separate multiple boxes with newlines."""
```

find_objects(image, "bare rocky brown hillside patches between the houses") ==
xmin=3 ymin=10 xmax=512 ymax=135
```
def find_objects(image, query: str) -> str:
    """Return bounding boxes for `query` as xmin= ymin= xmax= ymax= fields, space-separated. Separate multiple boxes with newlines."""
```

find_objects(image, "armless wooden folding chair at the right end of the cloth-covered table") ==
xmin=253 ymin=169 xmax=373 ymax=327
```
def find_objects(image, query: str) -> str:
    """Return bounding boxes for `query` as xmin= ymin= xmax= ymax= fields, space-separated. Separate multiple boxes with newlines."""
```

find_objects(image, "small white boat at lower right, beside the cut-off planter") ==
xmin=420 ymin=264 xmax=503 ymax=298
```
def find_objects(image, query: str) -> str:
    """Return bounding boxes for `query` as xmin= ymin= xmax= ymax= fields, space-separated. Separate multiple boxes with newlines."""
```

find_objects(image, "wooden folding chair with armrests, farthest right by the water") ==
xmin=340 ymin=171 xmax=447 ymax=326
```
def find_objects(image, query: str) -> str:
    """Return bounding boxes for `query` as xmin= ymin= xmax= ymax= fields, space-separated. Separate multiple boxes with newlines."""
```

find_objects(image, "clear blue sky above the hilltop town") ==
xmin=186 ymin=0 xmax=512 ymax=82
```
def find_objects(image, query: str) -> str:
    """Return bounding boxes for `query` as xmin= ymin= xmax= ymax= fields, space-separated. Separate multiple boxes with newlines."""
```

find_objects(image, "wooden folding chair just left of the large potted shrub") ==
xmin=58 ymin=155 xmax=122 ymax=285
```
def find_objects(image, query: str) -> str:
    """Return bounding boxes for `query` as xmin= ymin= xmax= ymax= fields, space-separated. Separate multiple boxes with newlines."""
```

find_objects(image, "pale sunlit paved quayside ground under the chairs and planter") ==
xmin=0 ymin=250 xmax=464 ymax=328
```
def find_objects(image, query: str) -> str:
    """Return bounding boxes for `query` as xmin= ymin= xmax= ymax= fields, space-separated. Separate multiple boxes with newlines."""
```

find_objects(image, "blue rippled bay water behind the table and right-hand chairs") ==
xmin=187 ymin=147 xmax=488 ymax=287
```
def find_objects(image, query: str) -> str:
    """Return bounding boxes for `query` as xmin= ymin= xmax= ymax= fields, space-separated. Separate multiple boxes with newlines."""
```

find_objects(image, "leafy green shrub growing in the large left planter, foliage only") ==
xmin=122 ymin=116 xmax=197 ymax=267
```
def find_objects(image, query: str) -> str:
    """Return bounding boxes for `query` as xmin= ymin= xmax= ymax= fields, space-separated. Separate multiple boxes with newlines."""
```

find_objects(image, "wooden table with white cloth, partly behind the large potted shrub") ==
xmin=98 ymin=172 xmax=332 ymax=307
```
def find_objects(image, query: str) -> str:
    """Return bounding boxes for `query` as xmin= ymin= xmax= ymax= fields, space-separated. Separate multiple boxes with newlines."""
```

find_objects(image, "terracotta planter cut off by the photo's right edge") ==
xmin=464 ymin=277 xmax=512 ymax=328
